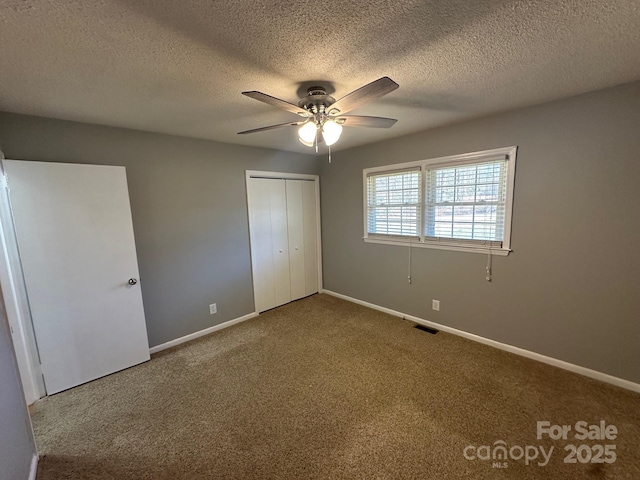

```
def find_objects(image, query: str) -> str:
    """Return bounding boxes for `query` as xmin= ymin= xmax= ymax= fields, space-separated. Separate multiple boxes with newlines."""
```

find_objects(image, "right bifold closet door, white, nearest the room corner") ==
xmin=285 ymin=180 xmax=318 ymax=300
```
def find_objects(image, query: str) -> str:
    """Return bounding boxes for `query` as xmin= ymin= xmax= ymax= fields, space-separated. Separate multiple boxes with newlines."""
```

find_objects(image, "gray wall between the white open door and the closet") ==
xmin=0 ymin=113 xmax=319 ymax=346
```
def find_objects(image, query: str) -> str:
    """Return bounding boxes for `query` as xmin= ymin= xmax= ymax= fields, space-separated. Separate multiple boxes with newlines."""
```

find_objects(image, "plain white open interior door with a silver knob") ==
xmin=4 ymin=160 xmax=149 ymax=394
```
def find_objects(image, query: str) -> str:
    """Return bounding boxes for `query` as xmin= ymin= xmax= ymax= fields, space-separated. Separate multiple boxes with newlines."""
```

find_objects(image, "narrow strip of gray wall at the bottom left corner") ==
xmin=0 ymin=288 xmax=36 ymax=480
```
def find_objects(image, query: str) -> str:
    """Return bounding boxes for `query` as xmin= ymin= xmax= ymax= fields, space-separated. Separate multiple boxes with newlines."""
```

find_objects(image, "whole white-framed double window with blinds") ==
xmin=364 ymin=147 xmax=516 ymax=255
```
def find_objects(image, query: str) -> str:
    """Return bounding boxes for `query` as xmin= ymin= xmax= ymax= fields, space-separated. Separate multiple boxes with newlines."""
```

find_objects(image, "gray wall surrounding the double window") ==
xmin=322 ymin=83 xmax=640 ymax=383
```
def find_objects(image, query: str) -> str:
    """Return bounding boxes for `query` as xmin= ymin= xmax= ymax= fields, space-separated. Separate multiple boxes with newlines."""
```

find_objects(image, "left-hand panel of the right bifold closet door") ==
xmin=286 ymin=180 xmax=311 ymax=300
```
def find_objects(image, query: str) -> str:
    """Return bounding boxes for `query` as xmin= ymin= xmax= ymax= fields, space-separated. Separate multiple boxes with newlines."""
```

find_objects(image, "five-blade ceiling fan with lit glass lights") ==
xmin=238 ymin=77 xmax=398 ymax=151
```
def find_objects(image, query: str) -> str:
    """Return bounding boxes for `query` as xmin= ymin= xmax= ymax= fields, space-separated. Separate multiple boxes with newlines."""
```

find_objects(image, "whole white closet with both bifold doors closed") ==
xmin=247 ymin=174 xmax=320 ymax=312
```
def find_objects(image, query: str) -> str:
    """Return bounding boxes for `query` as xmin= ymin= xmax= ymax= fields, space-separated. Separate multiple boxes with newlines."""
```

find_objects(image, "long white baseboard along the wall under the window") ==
xmin=323 ymin=290 xmax=640 ymax=393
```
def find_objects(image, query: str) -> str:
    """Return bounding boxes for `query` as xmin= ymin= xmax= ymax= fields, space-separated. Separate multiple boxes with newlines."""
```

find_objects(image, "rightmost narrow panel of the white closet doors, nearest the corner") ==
xmin=301 ymin=182 xmax=318 ymax=296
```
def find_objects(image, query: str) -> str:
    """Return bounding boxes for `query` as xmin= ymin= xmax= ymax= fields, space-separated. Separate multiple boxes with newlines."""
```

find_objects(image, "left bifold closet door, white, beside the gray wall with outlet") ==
xmin=248 ymin=178 xmax=291 ymax=312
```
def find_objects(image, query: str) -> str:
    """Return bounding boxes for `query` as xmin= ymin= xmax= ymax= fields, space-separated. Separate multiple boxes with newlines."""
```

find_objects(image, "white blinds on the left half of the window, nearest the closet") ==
xmin=367 ymin=167 xmax=422 ymax=237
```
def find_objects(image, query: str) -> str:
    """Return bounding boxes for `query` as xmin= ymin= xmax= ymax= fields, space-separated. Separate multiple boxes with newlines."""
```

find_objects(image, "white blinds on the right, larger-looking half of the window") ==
xmin=424 ymin=158 xmax=507 ymax=247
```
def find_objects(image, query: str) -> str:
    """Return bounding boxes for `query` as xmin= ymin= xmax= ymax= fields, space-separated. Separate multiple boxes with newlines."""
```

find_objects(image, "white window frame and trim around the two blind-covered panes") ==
xmin=362 ymin=146 xmax=518 ymax=256
